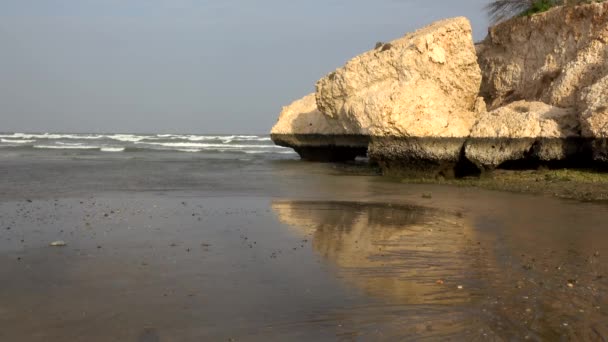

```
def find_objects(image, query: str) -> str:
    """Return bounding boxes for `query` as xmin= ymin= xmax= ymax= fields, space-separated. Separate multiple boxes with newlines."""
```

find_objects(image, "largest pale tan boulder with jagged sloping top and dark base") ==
xmin=316 ymin=18 xmax=481 ymax=176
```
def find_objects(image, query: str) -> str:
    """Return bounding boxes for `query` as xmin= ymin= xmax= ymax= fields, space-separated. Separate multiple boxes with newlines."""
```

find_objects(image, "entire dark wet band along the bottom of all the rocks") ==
xmin=272 ymin=135 xmax=608 ymax=175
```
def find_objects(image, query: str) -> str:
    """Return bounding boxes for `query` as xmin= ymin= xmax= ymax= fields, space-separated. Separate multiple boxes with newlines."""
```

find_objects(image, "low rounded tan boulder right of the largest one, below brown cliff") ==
xmin=464 ymin=101 xmax=581 ymax=170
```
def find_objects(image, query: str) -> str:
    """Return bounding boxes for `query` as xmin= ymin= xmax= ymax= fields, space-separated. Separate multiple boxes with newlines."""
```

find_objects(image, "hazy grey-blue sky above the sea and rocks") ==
xmin=0 ymin=0 xmax=487 ymax=133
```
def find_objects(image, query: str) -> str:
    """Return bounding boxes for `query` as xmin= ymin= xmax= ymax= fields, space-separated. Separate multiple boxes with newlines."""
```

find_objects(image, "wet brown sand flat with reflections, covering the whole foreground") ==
xmin=0 ymin=154 xmax=608 ymax=341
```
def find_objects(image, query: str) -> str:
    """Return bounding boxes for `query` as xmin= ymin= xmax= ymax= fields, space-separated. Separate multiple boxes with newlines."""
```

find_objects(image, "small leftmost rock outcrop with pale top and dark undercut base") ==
xmin=271 ymin=94 xmax=369 ymax=161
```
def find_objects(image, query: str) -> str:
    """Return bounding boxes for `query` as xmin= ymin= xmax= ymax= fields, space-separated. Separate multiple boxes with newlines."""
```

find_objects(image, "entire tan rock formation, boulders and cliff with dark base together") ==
xmin=272 ymin=2 xmax=608 ymax=177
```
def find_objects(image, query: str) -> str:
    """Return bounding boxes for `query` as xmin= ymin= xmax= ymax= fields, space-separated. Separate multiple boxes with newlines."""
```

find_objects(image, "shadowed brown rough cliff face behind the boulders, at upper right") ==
xmin=477 ymin=2 xmax=608 ymax=112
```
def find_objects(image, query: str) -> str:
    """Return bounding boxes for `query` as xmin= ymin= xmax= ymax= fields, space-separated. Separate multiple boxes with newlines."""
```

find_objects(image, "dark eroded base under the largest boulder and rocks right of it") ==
xmin=368 ymin=138 xmax=596 ymax=179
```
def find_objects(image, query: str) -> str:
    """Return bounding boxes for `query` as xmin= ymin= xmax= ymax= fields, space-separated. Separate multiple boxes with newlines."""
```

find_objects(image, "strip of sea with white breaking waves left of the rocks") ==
xmin=0 ymin=132 xmax=295 ymax=158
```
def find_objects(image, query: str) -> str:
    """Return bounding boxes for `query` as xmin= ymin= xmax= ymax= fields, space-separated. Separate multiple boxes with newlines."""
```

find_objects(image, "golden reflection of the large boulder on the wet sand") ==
xmin=273 ymin=202 xmax=472 ymax=304
